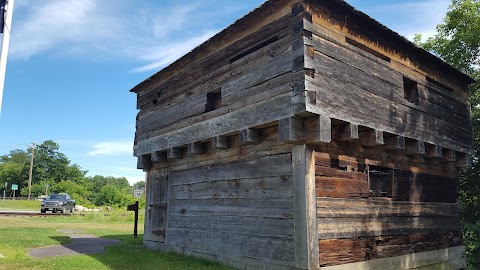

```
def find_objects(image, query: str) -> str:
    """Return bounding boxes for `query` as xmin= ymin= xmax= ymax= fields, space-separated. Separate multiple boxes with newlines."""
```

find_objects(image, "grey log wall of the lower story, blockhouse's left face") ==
xmin=145 ymin=127 xmax=295 ymax=269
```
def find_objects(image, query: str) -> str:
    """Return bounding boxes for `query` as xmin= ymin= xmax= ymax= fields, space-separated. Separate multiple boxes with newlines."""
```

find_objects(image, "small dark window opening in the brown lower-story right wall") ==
xmin=368 ymin=166 xmax=394 ymax=198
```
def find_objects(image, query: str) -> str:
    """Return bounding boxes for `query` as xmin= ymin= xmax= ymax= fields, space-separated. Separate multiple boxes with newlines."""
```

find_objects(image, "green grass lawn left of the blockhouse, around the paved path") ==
xmin=0 ymin=214 xmax=232 ymax=270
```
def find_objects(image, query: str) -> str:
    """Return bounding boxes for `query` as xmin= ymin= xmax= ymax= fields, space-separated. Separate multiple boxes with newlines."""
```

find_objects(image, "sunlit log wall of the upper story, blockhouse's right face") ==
xmin=292 ymin=1 xmax=472 ymax=153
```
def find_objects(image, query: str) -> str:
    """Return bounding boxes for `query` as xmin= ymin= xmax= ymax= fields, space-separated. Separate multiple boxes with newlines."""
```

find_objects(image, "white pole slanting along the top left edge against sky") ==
xmin=0 ymin=0 xmax=14 ymax=113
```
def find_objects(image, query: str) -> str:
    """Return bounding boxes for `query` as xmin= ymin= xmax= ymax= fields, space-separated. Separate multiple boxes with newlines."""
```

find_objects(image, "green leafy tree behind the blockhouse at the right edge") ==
xmin=414 ymin=0 xmax=480 ymax=269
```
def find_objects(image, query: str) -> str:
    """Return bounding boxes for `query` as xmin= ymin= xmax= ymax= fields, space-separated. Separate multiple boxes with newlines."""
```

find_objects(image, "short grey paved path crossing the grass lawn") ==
xmin=28 ymin=230 xmax=120 ymax=258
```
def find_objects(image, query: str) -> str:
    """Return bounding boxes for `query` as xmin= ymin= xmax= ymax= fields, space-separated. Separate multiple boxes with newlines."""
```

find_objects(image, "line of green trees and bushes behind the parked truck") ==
xmin=0 ymin=140 xmax=145 ymax=207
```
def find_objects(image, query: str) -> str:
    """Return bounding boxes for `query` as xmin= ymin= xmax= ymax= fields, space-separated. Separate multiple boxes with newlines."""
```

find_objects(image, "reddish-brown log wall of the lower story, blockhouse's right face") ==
xmin=315 ymin=150 xmax=462 ymax=266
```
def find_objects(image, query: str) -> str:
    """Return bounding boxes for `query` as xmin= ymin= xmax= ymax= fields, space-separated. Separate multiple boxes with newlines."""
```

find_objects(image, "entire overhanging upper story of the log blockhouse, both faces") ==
xmin=131 ymin=0 xmax=473 ymax=168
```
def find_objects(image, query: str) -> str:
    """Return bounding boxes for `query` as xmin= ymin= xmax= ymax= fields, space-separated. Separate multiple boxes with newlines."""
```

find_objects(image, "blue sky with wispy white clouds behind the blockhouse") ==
xmin=0 ymin=0 xmax=450 ymax=183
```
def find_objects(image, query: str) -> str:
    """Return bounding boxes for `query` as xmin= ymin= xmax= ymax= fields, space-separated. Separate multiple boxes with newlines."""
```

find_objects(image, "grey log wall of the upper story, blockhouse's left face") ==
xmin=135 ymin=0 xmax=303 ymax=156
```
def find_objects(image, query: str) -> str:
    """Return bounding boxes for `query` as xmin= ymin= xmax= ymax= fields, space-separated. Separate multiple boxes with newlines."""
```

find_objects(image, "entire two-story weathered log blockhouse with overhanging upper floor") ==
xmin=131 ymin=0 xmax=473 ymax=270
